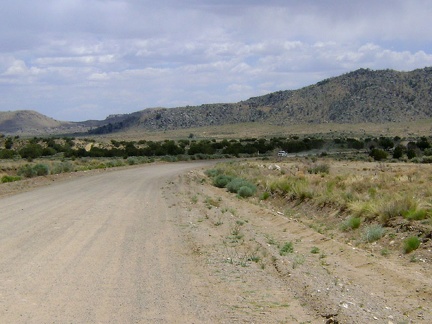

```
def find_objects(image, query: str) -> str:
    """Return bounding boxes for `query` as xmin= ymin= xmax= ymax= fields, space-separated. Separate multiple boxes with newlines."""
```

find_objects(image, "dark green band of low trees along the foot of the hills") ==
xmin=0 ymin=136 xmax=432 ymax=160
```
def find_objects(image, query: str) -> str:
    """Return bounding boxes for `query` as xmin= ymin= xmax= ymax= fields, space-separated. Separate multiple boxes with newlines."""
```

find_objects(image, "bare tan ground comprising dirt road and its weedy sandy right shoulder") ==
xmin=0 ymin=162 xmax=432 ymax=323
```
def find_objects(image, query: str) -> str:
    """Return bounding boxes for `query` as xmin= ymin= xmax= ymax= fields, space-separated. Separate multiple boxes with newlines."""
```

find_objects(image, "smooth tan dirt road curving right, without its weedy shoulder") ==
xmin=0 ymin=163 xmax=226 ymax=323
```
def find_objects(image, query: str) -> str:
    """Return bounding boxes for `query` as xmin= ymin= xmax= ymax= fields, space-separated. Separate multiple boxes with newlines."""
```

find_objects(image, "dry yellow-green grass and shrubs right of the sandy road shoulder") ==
xmin=206 ymin=157 xmax=432 ymax=255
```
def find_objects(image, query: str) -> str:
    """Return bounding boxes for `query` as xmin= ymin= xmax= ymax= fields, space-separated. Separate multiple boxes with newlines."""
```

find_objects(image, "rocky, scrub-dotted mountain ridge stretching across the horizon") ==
xmin=0 ymin=67 xmax=432 ymax=134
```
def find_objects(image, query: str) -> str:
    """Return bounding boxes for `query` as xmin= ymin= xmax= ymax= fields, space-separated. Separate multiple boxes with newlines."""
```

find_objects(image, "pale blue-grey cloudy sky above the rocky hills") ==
xmin=0 ymin=0 xmax=432 ymax=121
